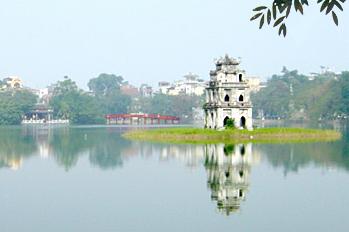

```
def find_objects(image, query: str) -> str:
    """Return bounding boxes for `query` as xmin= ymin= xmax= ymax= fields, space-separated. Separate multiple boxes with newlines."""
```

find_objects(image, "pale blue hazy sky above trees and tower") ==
xmin=0 ymin=0 xmax=349 ymax=88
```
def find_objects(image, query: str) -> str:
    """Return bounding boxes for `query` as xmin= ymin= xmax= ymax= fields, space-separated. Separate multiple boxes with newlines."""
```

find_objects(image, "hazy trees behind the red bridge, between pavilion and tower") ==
xmin=50 ymin=74 xmax=203 ymax=124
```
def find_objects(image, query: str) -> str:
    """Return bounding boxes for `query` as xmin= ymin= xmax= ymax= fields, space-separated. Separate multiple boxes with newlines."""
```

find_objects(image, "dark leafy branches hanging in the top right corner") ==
xmin=250 ymin=0 xmax=346 ymax=37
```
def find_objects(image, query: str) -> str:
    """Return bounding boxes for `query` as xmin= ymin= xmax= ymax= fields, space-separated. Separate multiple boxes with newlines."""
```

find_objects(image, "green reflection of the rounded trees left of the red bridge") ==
xmin=51 ymin=128 xmax=130 ymax=170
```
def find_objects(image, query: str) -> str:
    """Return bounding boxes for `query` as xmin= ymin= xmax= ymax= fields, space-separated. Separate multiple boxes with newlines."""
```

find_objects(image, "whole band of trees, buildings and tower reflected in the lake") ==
xmin=0 ymin=124 xmax=349 ymax=215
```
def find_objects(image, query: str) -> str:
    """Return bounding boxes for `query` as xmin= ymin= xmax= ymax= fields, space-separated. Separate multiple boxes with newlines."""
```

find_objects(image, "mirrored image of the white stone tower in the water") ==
xmin=205 ymin=144 xmax=259 ymax=215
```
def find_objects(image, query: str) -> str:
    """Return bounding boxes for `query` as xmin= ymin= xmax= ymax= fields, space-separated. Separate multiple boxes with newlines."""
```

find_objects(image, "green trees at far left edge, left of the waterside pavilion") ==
xmin=0 ymin=89 xmax=36 ymax=125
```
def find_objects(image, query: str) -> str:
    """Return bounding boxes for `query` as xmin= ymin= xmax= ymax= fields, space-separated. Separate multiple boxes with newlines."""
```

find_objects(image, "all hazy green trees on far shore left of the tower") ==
xmin=0 ymin=74 xmax=204 ymax=125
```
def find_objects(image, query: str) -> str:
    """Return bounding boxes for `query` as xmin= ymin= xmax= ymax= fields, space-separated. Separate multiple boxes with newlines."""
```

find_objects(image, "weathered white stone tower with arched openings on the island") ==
xmin=204 ymin=55 xmax=253 ymax=130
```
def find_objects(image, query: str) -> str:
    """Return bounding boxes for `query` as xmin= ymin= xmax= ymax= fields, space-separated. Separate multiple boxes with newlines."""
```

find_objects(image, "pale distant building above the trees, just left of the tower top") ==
xmin=159 ymin=73 xmax=206 ymax=96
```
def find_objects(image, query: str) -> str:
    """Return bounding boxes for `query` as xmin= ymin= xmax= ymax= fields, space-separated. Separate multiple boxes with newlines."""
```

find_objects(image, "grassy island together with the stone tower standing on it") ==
xmin=124 ymin=55 xmax=341 ymax=143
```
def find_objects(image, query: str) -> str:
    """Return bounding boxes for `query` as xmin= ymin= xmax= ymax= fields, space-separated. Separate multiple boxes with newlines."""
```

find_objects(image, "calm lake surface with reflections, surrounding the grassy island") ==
xmin=0 ymin=126 xmax=349 ymax=232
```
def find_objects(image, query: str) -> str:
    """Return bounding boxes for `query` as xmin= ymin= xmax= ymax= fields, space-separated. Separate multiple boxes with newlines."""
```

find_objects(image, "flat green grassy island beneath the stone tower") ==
xmin=123 ymin=128 xmax=341 ymax=143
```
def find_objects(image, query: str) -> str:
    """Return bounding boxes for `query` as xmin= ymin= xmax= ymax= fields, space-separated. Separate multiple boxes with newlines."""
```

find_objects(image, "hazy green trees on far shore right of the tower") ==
xmin=251 ymin=68 xmax=349 ymax=120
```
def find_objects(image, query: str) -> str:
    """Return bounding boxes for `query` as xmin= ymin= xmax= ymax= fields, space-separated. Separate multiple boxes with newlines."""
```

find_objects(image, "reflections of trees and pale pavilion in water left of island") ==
xmin=0 ymin=127 xmax=130 ymax=171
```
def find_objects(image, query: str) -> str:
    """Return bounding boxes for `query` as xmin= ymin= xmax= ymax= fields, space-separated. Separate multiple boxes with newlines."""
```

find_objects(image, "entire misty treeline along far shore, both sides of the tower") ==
xmin=0 ymin=68 xmax=349 ymax=125
